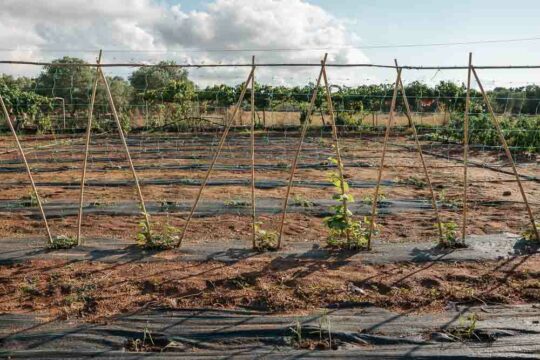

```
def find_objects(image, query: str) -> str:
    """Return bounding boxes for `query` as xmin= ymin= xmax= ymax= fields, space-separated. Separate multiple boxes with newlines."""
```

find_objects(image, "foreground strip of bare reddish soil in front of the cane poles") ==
xmin=0 ymin=255 xmax=540 ymax=321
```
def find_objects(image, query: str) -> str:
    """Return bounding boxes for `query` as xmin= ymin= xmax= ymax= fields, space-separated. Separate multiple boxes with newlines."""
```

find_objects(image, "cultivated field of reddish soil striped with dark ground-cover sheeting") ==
xmin=0 ymin=129 xmax=540 ymax=358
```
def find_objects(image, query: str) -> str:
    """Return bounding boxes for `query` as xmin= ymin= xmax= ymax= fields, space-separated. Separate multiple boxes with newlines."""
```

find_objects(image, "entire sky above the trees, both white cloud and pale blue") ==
xmin=0 ymin=0 xmax=540 ymax=88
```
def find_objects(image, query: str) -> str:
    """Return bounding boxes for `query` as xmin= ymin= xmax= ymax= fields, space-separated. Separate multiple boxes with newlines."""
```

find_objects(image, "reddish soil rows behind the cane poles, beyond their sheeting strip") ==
xmin=0 ymin=134 xmax=540 ymax=243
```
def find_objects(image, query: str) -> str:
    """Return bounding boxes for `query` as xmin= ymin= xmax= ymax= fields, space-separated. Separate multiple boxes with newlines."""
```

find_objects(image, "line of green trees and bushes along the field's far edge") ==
xmin=0 ymin=57 xmax=540 ymax=130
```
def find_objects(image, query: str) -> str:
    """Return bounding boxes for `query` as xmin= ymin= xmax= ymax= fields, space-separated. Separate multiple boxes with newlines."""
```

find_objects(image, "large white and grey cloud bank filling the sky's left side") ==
xmin=0 ymin=0 xmax=368 ymax=84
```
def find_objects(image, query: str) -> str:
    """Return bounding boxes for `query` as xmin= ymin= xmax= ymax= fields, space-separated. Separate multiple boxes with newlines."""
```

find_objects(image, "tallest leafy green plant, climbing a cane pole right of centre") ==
xmin=324 ymin=159 xmax=370 ymax=250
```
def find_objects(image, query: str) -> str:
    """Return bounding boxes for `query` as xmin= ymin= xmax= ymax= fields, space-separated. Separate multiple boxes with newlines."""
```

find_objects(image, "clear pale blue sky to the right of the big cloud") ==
xmin=157 ymin=0 xmax=540 ymax=86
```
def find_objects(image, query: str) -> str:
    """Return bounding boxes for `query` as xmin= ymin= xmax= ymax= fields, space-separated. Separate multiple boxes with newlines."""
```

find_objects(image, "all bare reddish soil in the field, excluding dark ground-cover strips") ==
xmin=0 ymin=134 xmax=540 ymax=321
